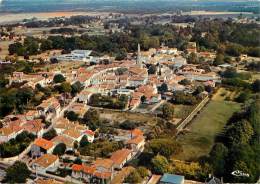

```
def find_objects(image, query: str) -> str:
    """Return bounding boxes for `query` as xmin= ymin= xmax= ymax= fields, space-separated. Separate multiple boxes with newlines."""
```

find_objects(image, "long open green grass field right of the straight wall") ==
xmin=175 ymin=100 xmax=240 ymax=161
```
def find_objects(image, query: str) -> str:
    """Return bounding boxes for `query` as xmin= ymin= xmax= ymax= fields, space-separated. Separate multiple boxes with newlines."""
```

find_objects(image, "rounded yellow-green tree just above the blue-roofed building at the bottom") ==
xmin=152 ymin=155 xmax=170 ymax=174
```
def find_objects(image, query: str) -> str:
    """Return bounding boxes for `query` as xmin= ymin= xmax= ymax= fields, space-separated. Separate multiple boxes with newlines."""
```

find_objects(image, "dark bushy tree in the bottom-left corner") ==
xmin=4 ymin=161 xmax=31 ymax=183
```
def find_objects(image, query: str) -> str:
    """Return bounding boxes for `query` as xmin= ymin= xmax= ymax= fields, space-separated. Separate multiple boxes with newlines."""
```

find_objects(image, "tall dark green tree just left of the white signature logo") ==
xmin=209 ymin=143 xmax=228 ymax=177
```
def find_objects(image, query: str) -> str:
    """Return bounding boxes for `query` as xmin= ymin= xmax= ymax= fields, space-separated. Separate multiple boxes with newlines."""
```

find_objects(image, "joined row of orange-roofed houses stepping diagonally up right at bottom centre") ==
xmin=72 ymin=129 xmax=145 ymax=183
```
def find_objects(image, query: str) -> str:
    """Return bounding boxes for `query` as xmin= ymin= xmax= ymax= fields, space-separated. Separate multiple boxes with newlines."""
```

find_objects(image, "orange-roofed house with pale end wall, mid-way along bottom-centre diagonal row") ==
xmin=110 ymin=149 xmax=133 ymax=169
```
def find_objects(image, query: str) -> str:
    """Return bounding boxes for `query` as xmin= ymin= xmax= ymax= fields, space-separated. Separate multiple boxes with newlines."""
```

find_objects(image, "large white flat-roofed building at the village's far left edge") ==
xmin=53 ymin=50 xmax=92 ymax=62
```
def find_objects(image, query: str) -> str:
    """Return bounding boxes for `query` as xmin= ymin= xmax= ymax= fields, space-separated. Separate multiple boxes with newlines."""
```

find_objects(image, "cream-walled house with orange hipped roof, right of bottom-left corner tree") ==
xmin=32 ymin=154 xmax=59 ymax=173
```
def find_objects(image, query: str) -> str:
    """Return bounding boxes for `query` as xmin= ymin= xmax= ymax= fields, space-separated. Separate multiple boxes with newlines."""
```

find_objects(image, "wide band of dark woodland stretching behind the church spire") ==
xmin=9 ymin=19 xmax=260 ymax=57
